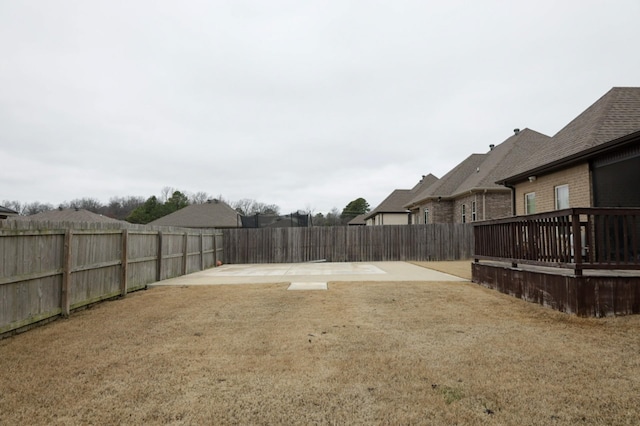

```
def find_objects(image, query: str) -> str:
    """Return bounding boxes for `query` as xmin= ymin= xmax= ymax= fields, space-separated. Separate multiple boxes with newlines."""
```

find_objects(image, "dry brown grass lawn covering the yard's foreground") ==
xmin=0 ymin=270 xmax=640 ymax=425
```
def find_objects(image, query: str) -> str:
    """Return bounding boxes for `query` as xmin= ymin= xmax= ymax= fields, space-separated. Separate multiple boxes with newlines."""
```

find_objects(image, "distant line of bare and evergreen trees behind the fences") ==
xmin=2 ymin=186 xmax=370 ymax=226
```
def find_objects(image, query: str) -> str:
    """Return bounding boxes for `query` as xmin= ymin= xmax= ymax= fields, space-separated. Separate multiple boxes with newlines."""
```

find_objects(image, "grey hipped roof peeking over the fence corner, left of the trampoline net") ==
xmin=149 ymin=200 xmax=241 ymax=228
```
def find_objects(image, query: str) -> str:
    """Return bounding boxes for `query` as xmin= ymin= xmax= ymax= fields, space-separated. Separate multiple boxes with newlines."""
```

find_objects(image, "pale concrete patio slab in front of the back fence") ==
xmin=151 ymin=262 xmax=468 ymax=286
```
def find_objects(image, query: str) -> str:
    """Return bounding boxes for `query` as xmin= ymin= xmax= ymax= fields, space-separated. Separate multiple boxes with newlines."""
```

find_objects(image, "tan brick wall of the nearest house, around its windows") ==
xmin=516 ymin=163 xmax=592 ymax=215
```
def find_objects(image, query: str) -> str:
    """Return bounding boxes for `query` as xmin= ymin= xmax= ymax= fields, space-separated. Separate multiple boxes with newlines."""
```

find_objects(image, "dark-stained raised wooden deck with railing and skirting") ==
xmin=472 ymin=209 xmax=640 ymax=317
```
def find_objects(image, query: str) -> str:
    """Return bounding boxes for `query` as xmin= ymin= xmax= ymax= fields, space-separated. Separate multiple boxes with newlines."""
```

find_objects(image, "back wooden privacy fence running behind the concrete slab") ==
xmin=223 ymin=224 xmax=473 ymax=263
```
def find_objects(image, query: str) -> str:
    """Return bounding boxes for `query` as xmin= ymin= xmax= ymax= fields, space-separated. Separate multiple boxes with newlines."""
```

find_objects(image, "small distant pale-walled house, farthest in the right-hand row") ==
xmin=364 ymin=173 xmax=438 ymax=226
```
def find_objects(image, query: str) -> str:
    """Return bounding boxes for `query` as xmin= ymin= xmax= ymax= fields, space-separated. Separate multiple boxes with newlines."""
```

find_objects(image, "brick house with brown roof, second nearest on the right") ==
xmin=405 ymin=129 xmax=549 ymax=223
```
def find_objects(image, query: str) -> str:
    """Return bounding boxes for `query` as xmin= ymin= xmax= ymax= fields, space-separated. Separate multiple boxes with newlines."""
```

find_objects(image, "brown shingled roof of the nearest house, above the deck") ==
xmin=499 ymin=87 xmax=640 ymax=183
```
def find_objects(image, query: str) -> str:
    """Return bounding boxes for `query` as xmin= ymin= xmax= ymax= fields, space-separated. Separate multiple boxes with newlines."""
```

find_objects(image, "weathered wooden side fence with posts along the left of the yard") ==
xmin=0 ymin=229 xmax=222 ymax=336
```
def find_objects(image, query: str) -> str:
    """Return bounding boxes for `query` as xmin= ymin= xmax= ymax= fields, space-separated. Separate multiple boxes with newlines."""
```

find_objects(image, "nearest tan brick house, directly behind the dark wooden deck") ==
xmin=498 ymin=87 xmax=640 ymax=215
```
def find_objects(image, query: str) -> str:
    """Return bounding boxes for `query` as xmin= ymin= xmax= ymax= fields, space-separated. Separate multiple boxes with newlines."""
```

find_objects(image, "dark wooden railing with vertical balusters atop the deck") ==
xmin=473 ymin=208 xmax=640 ymax=275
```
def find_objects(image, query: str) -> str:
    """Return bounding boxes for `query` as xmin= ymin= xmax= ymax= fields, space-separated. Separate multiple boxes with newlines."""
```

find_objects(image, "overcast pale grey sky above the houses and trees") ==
xmin=0 ymin=0 xmax=640 ymax=213
